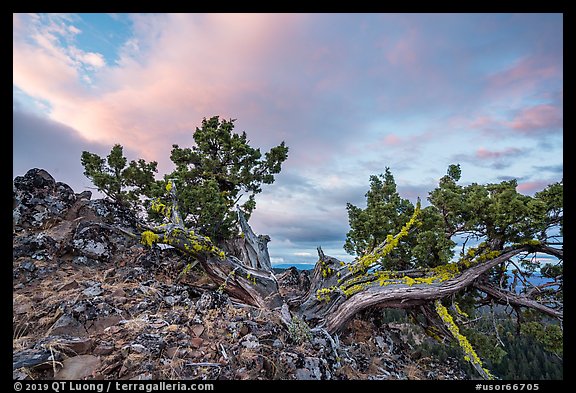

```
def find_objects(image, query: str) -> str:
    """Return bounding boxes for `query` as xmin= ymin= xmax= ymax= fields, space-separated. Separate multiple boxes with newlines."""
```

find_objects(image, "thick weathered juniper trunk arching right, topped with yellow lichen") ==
xmin=298 ymin=246 xmax=558 ymax=333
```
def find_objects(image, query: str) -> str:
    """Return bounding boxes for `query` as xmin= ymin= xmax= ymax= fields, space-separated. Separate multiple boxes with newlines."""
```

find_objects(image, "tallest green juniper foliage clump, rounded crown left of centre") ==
xmin=164 ymin=116 xmax=288 ymax=241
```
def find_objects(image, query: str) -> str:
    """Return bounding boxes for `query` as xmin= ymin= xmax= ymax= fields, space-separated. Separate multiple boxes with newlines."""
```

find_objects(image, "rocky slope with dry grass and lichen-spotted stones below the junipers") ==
xmin=13 ymin=169 xmax=466 ymax=379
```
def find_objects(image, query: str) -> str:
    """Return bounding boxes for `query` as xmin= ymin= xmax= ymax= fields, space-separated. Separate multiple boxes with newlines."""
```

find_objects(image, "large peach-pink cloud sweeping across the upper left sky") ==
xmin=13 ymin=14 xmax=306 ymax=164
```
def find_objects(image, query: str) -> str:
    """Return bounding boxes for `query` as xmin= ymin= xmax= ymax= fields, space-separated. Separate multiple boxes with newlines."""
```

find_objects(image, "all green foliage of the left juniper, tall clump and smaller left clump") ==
xmin=81 ymin=116 xmax=288 ymax=243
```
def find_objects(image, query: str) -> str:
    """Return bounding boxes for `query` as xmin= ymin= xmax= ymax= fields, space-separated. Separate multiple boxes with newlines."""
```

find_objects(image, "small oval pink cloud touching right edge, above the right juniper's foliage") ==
xmin=508 ymin=104 xmax=563 ymax=133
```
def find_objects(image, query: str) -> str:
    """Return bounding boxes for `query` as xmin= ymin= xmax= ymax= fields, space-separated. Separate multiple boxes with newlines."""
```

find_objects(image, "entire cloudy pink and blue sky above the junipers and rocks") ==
xmin=13 ymin=13 xmax=563 ymax=264
